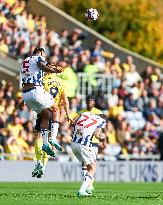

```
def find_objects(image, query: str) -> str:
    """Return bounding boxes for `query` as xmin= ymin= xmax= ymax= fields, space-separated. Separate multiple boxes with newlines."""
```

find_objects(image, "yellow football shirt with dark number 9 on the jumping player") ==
xmin=43 ymin=73 xmax=65 ymax=107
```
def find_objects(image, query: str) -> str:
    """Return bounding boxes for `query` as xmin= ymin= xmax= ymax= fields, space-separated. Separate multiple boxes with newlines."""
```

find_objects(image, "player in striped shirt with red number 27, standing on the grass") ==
xmin=71 ymin=112 xmax=106 ymax=196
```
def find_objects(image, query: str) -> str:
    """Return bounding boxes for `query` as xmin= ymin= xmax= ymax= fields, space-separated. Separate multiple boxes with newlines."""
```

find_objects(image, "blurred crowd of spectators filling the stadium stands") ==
xmin=0 ymin=0 xmax=163 ymax=160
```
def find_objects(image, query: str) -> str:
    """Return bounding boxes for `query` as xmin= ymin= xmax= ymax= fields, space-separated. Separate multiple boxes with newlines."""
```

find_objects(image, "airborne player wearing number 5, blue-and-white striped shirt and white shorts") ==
xmin=21 ymin=48 xmax=62 ymax=157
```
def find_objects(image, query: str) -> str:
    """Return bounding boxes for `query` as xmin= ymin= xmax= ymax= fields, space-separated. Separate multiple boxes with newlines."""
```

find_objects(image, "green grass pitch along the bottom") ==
xmin=0 ymin=182 xmax=163 ymax=205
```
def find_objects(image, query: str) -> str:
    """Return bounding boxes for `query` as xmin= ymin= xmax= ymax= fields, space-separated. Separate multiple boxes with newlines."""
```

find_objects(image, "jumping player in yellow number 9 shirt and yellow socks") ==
xmin=32 ymin=73 xmax=69 ymax=178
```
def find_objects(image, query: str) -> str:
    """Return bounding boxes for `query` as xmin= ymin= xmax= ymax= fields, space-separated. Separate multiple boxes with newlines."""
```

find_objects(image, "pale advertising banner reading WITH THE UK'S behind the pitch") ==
xmin=0 ymin=161 xmax=163 ymax=182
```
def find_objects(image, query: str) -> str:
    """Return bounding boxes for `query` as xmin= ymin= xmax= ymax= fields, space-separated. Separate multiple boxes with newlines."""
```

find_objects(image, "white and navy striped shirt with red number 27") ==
xmin=72 ymin=112 xmax=106 ymax=146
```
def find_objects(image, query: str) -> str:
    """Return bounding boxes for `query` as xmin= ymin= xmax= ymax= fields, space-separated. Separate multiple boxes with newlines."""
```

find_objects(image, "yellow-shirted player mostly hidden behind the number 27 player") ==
xmin=78 ymin=95 xmax=105 ymax=191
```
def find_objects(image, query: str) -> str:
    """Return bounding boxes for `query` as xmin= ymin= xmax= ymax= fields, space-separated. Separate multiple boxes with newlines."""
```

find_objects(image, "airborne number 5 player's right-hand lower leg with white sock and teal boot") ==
xmin=49 ymin=108 xmax=62 ymax=151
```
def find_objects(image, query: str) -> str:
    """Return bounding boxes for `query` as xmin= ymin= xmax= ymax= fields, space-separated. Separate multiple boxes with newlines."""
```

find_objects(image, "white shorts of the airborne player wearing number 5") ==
xmin=23 ymin=86 xmax=54 ymax=113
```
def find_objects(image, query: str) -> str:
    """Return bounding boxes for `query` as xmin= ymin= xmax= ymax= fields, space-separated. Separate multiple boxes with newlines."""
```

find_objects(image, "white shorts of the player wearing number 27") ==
xmin=71 ymin=142 xmax=96 ymax=165
